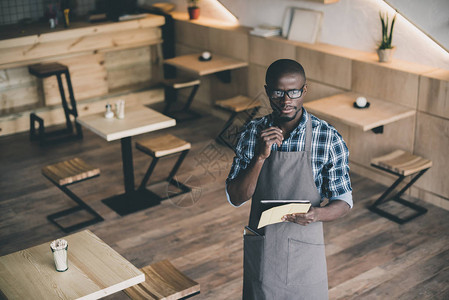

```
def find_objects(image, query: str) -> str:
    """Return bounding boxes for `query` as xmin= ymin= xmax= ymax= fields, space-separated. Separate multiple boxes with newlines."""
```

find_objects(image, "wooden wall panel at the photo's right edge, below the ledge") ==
xmin=418 ymin=69 xmax=449 ymax=119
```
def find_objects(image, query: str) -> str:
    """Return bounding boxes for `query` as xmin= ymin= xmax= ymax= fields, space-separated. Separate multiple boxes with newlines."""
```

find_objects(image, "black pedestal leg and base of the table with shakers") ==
xmin=103 ymin=137 xmax=160 ymax=216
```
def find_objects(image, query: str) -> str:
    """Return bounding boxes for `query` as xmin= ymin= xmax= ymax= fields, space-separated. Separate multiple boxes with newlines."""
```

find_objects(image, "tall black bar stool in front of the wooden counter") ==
xmin=28 ymin=63 xmax=83 ymax=143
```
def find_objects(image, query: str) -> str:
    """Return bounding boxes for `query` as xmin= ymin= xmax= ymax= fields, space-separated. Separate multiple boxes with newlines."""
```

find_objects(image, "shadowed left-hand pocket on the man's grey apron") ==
xmin=243 ymin=235 xmax=265 ymax=281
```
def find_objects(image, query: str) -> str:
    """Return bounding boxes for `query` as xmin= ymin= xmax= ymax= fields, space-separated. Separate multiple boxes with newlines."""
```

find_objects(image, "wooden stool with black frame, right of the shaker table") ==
xmin=136 ymin=134 xmax=191 ymax=200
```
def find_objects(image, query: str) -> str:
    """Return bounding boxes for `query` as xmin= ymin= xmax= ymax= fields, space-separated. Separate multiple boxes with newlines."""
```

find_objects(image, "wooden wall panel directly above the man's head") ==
xmin=249 ymin=36 xmax=296 ymax=67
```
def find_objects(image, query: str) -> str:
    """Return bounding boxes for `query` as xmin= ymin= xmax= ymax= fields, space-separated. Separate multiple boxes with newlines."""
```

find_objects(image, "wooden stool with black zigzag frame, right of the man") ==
xmin=369 ymin=150 xmax=432 ymax=224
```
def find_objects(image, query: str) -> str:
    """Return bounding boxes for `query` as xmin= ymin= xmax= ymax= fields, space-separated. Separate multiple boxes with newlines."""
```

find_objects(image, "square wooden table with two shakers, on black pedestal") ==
xmin=77 ymin=105 xmax=176 ymax=216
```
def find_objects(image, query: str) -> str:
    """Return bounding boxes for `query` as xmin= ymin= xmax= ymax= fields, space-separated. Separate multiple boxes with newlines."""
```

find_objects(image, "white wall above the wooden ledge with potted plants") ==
xmin=162 ymin=0 xmax=449 ymax=70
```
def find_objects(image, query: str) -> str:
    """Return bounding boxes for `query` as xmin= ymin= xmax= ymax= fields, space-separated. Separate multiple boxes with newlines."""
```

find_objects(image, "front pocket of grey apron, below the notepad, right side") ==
xmin=287 ymin=239 xmax=327 ymax=285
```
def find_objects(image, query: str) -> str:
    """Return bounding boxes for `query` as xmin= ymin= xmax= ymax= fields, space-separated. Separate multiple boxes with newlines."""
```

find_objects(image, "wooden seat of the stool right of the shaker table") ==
xmin=136 ymin=134 xmax=191 ymax=157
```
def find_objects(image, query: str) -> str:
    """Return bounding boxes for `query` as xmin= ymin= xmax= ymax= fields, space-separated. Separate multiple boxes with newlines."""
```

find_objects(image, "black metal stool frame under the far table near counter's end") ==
xmin=163 ymin=84 xmax=201 ymax=122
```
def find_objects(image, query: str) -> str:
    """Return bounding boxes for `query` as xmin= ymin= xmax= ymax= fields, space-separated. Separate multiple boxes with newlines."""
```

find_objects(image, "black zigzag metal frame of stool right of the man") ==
xmin=368 ymin=164 xmax=429 ymax=224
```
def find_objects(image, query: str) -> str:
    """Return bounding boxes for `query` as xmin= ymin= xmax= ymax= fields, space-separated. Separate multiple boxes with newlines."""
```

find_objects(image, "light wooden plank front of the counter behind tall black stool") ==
xmin=0 ymin=15 xmax=165 ymax=136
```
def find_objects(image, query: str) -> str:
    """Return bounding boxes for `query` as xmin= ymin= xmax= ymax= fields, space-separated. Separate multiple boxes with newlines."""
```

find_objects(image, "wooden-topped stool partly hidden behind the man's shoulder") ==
xmin=215 ymin=95 xmax=261 ymax=149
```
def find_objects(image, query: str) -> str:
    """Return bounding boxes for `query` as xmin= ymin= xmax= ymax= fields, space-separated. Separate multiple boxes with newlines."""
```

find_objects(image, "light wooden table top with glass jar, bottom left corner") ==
xmin=0 ymin=230 xmax=145 ymax=299
